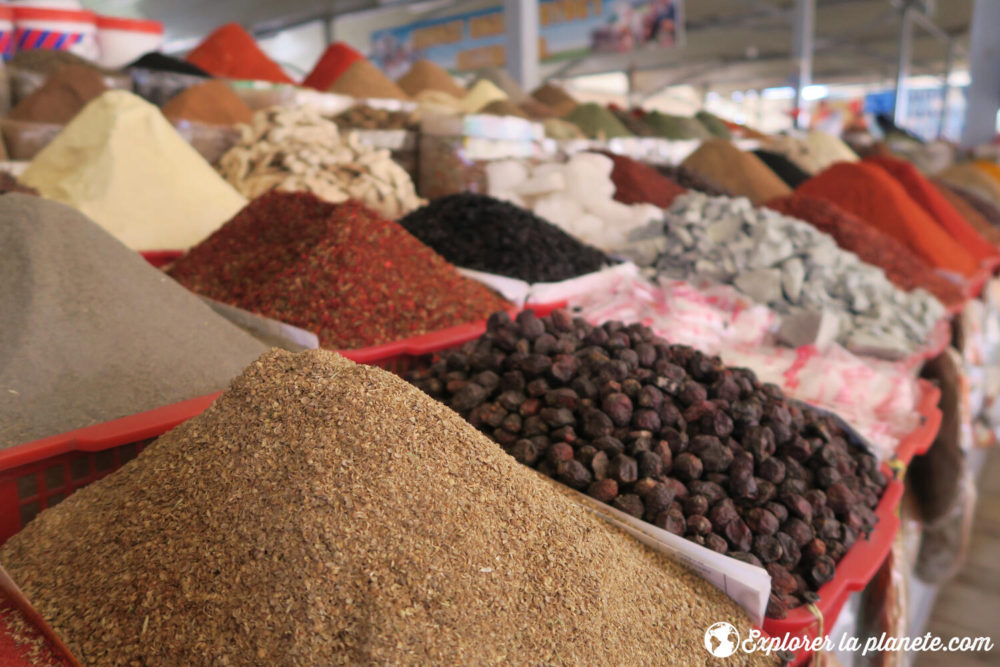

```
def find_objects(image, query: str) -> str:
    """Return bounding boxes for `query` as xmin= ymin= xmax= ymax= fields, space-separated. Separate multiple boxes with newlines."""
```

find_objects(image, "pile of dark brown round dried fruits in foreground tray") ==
xmin=410 ymin=311 xmax=886 ymax=618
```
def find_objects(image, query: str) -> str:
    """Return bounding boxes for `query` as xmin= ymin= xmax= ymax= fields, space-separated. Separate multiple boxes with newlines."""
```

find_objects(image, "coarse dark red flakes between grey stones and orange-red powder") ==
xmin=767 ymin=194 xmax=965 ymax=307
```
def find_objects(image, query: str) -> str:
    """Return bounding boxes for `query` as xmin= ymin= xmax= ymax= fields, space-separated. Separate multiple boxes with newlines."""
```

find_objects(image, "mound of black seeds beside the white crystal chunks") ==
xmin=399 ymin=192 xmax=611 ymax=283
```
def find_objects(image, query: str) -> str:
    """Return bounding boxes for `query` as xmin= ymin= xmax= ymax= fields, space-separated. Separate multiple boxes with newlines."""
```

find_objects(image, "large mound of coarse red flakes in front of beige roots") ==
xmin=170 ymin=192 xmax=509 ymax=349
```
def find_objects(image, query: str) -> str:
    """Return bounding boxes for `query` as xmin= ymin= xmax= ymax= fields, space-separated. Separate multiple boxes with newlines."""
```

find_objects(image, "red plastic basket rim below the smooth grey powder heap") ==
xmin=0 ymin=392 xmax=222 ymax=473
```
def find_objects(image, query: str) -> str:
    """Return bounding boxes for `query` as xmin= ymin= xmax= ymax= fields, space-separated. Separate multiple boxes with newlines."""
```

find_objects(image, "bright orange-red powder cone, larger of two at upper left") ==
xmin=187 ymin=23 xmax=293 ymax=83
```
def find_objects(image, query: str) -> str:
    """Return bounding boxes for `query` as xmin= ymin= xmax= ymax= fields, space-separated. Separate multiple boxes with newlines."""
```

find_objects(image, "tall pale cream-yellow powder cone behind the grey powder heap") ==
xmin=22 ymin=90 xmax=246 ymax=250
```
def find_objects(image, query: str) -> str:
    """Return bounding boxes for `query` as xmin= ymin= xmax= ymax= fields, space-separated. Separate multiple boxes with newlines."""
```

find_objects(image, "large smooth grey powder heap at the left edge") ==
xmin=0 ymin=193 xmax=265 ymax=448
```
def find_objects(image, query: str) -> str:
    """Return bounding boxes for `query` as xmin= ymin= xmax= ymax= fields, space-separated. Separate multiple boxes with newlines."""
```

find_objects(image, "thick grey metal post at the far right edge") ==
xmin=962 ymin=0 xmax=1000 ymax=147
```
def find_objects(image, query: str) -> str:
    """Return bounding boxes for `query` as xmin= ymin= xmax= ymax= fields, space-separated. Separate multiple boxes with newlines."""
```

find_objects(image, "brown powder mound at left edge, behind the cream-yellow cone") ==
xmin=9 ymin=65 xmax=107 ymax=125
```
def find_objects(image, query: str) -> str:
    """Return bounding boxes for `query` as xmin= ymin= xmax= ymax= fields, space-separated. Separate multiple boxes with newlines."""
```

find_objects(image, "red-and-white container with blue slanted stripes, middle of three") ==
xmin=14 ymin=6 xmax=98 ymax=60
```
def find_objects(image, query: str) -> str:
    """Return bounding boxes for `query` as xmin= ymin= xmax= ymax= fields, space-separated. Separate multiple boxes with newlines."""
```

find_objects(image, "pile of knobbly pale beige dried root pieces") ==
xmin=219 ymin=107 xmax=422 ymax=219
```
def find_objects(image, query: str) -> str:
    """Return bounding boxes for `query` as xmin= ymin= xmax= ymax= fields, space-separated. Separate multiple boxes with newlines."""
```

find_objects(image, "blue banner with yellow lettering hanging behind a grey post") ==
xmin=371 ymin=0 xmax=684 ymax=77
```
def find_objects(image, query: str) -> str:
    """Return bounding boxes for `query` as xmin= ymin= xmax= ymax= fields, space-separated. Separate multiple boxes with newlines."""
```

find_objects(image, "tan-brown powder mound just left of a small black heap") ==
xmin=681 ymin=139 xmax=792 ymax=205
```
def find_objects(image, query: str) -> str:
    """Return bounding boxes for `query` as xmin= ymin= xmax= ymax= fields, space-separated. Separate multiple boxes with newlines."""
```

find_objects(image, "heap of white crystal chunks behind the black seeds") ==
xmin=486 ymin=153 xmax=663 ymax=250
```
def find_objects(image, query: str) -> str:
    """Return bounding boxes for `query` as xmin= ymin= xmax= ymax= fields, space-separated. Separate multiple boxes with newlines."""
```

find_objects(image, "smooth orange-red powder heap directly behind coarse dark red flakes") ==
xmin=796 ymin=162 xmax=979 ymax=276
